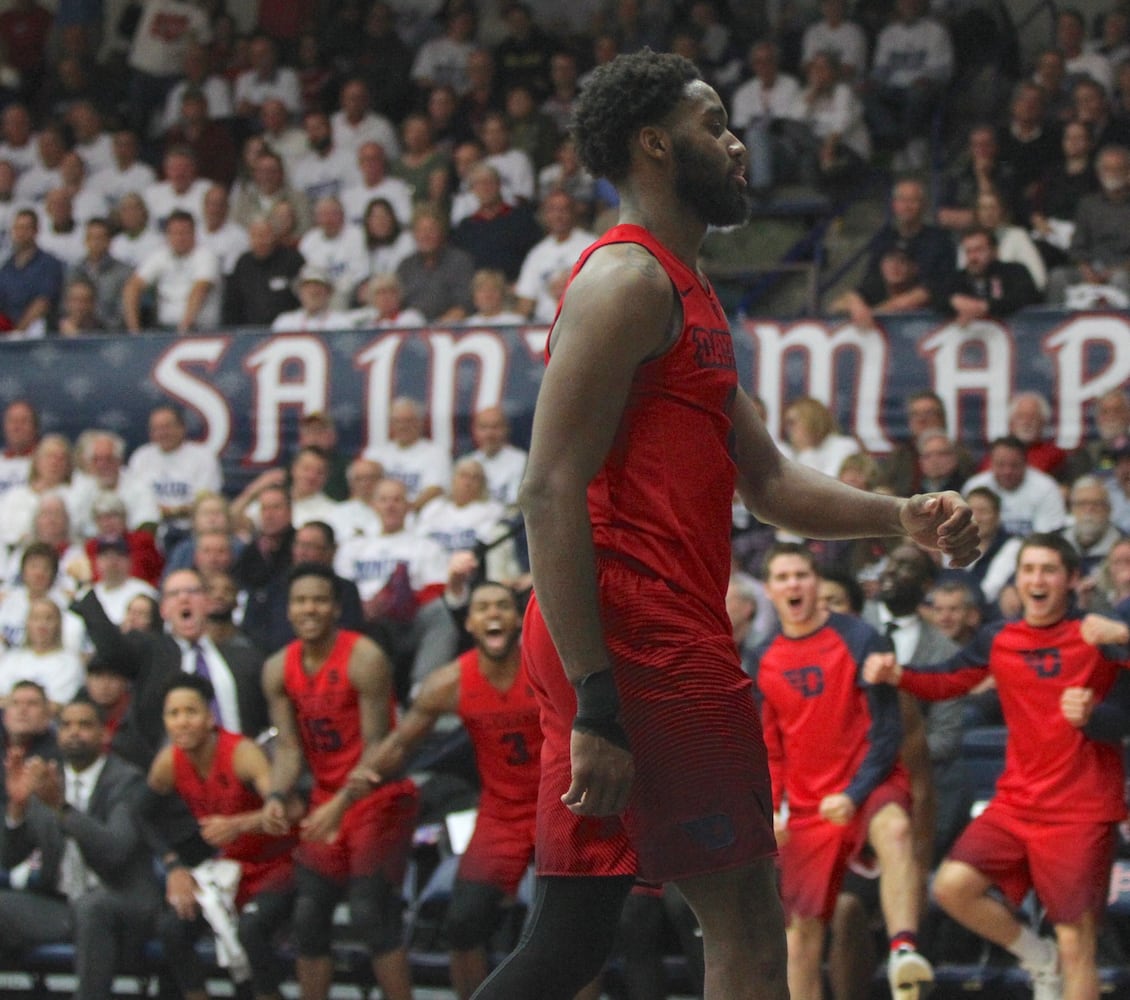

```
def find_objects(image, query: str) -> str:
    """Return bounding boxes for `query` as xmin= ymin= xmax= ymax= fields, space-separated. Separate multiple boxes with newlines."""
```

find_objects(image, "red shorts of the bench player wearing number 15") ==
xmin=294 ymin=781 xmax=419 ymax=886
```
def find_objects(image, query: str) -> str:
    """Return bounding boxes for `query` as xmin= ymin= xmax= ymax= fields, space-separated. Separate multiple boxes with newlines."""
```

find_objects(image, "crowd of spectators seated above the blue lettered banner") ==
xmin=0 ymin=0 xmax=1130 ymax=337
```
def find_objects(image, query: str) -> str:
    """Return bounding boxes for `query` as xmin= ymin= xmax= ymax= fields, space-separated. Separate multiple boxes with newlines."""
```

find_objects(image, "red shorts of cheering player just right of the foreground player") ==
xmin=780 ymin=768 xmax=911 ymax=923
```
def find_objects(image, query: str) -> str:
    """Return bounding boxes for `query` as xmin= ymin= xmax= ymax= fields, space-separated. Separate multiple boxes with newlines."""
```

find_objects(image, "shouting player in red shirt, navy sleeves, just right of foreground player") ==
xmin=755 ymin=542 xmax=933 ymax=1000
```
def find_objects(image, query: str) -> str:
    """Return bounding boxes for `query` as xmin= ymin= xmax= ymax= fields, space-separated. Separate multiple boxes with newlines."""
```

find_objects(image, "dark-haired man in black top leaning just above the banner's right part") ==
xmin=936 ymin=228 xmax=1041 ymax=327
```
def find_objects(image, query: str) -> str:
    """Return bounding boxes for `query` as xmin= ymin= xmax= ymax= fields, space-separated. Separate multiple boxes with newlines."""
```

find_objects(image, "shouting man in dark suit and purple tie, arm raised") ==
xmin=73 ymin=569 xmax=268 ymax=768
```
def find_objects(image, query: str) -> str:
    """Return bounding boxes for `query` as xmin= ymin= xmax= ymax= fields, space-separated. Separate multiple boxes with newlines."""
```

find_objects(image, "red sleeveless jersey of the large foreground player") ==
xmin=550 ymin=225 xmax=738 ymax=632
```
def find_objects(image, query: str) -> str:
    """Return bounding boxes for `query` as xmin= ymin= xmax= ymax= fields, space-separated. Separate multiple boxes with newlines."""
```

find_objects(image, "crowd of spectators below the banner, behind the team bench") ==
xmin=0 ymin=386 xmax=1130 ymax=985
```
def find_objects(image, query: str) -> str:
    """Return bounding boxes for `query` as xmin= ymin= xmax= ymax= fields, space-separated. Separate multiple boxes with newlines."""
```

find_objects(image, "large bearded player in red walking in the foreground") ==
xmin=467 ymin=51 xmax=976 ymax=1000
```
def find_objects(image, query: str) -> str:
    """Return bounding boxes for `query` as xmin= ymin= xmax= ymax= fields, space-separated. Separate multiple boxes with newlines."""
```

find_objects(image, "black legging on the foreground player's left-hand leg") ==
xmin=465 ymin=876 xmax=634 ymax=1000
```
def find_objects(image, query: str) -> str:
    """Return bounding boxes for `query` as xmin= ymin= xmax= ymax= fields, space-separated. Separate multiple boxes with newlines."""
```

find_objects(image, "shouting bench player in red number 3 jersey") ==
xmin=373 ymin=582 xmax=596 ymax=1000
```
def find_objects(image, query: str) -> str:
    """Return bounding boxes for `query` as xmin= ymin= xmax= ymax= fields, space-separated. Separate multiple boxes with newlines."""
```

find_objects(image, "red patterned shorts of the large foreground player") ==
xmin=522 ymin=558 xmax=776 ymax=882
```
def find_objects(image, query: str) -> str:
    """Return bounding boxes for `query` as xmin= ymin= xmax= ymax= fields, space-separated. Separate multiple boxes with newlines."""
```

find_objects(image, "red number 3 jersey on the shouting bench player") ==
xmin=458 ymin=650 xmax=541 ymax=812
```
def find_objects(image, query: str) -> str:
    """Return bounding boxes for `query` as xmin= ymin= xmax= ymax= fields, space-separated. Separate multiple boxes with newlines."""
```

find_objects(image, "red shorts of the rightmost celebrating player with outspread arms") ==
xmin=949 ymin=802 xmax=1115 ymax=923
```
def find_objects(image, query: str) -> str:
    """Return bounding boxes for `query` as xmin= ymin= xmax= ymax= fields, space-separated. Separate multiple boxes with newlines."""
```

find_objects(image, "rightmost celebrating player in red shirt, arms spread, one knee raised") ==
xmin=864 ymin=534 xmax=1130 ymax=1000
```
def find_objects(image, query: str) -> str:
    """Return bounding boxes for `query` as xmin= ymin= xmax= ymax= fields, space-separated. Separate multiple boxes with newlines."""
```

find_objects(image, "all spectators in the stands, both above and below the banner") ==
xmin=0 ymin=0 xmax=1130 ymax=994
